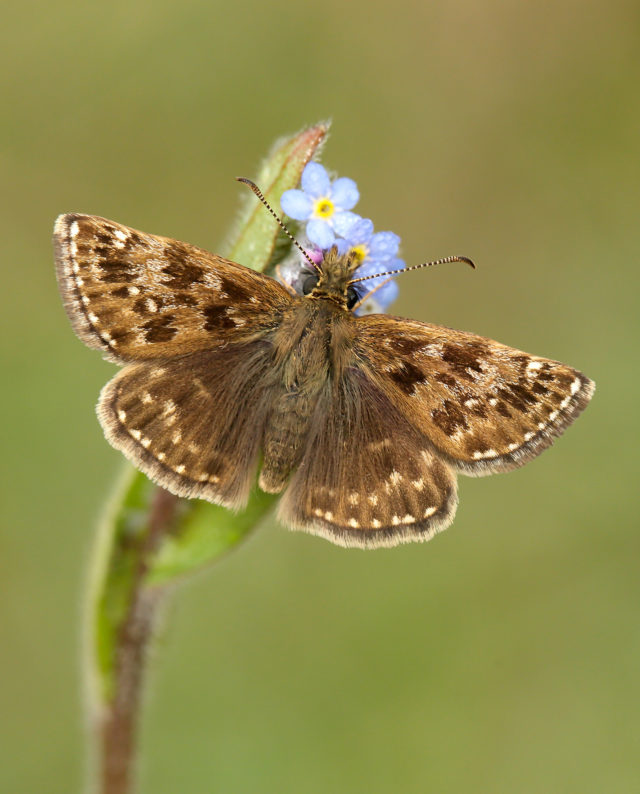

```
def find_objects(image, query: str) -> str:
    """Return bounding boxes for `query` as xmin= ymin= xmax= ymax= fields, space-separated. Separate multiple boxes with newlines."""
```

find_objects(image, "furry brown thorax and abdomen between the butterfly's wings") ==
xmin=260 ymin=284 xmax=356 ymax=493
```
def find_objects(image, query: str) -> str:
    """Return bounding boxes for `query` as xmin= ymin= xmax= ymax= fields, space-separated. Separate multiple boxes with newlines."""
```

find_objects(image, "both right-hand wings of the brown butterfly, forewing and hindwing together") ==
xmin=280 ymin=315 xmax=594 ymax=547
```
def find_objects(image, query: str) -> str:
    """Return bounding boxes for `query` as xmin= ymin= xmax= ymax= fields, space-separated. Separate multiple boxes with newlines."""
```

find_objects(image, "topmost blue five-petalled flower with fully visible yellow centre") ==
xmin=280 ymin=163 xmax=360 ymax=249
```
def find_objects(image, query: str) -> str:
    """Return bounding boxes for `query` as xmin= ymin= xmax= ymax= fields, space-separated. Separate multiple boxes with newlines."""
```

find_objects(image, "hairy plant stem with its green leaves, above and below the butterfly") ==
xmin=86 ymin=123 xmax=328 ymax=794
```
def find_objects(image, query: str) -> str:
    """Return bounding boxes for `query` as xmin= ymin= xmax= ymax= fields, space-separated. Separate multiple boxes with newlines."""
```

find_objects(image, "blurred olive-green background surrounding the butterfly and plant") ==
xmin=0 ymin=0 xmax=640 ymax=794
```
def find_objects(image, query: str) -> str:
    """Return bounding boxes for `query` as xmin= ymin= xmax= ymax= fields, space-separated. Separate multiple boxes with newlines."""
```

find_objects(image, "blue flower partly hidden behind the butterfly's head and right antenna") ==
xmin=336 ymin=218 xmax=406 ymax=314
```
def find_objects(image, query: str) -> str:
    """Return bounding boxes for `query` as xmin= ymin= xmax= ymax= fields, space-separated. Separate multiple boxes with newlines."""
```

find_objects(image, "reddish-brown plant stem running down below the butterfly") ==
xmin=97 ymin=487 xmax=178 ymax=794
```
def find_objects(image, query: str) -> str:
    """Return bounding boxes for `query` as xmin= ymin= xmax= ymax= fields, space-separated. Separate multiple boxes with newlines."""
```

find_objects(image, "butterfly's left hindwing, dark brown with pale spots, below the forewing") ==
xmin=97 ymin=341 xmax=272 ymax=508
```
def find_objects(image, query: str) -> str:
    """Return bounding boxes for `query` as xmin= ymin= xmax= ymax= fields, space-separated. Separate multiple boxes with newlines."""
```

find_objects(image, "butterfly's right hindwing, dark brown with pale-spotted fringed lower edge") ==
xmin=279 ymin=368 xmax=457 ymax=548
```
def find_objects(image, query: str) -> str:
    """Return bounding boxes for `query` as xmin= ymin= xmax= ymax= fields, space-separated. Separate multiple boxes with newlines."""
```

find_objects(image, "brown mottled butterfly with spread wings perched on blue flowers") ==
xmin=54 ymin=195 xmax=594 ymax=548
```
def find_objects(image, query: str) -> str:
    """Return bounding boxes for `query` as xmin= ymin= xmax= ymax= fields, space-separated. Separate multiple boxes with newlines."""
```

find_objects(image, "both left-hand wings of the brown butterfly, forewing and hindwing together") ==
xmin=54 ymin=215 xmax=291 ymax=507
